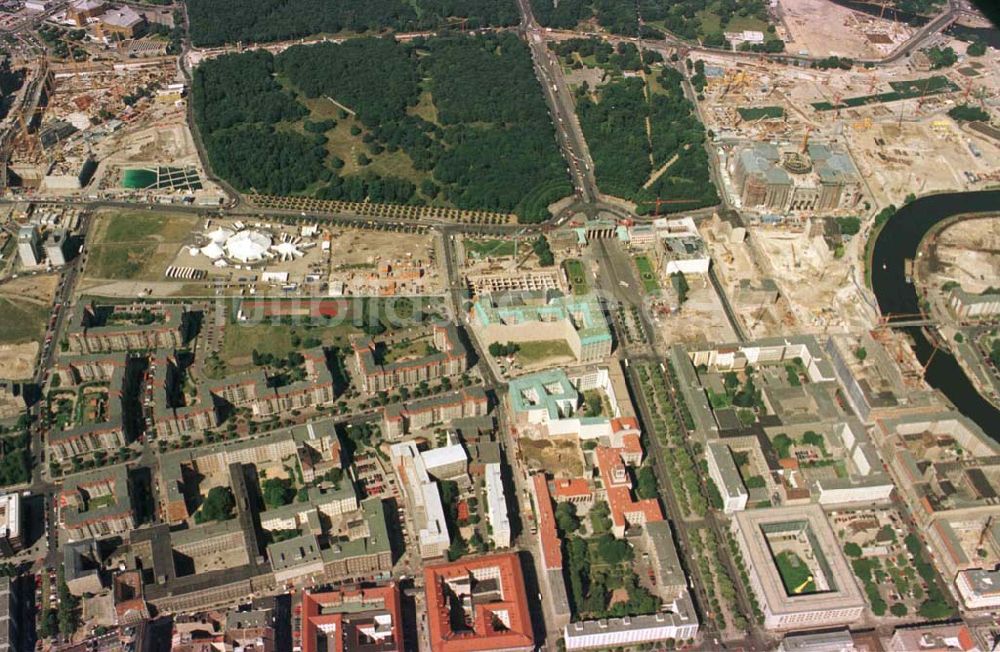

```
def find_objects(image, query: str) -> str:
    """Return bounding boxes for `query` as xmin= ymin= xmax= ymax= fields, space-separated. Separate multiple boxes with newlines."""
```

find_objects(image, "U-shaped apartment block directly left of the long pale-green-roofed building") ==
xmin=353 ymin=326 xmax=467 ymax=394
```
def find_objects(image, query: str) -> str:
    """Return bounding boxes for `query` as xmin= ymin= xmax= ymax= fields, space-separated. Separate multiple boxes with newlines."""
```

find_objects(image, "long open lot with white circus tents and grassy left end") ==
xmin=83 ymin=212 xmax=444 ymax=297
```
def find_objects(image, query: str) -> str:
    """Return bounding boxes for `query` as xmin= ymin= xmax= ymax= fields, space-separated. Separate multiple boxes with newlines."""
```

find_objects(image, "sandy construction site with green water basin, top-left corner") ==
xmin=0 ymin=11 xmax=225 ymax=205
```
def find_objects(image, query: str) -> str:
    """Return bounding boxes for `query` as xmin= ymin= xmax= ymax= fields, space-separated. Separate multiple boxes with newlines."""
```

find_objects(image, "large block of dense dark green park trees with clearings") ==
xmin=193 ymin=33 xmax=572 ymax=221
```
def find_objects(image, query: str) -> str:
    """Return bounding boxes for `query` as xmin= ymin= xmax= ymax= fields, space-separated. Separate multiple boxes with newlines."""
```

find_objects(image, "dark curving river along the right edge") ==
xmin=872 ymin=190 xmax=1000 ymax=441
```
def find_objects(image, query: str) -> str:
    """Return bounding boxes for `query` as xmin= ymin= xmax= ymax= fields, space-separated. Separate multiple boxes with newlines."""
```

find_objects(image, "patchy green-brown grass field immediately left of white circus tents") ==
xmin=84 ymin=212 xmax=198 ymax=281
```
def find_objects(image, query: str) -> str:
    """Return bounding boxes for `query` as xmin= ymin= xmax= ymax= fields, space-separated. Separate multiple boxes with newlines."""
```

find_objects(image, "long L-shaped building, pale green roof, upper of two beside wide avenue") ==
xmin=471 ymin=291 xmax=612 ymax=362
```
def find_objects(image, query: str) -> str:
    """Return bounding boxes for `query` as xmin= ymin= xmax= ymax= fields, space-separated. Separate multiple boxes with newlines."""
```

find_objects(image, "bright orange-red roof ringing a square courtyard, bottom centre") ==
xmin=424 ymin=553 xmax=535 ymax=652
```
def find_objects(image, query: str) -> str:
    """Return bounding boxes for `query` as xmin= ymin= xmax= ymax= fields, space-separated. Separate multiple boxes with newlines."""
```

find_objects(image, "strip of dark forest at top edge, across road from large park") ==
xmin=187 ymin=0 xmax=518 ymax=47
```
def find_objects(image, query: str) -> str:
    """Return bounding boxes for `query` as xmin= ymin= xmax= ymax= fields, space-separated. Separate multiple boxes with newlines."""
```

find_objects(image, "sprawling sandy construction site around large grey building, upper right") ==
xmin=700 ymin=37 xmax=1000 ymax=211
